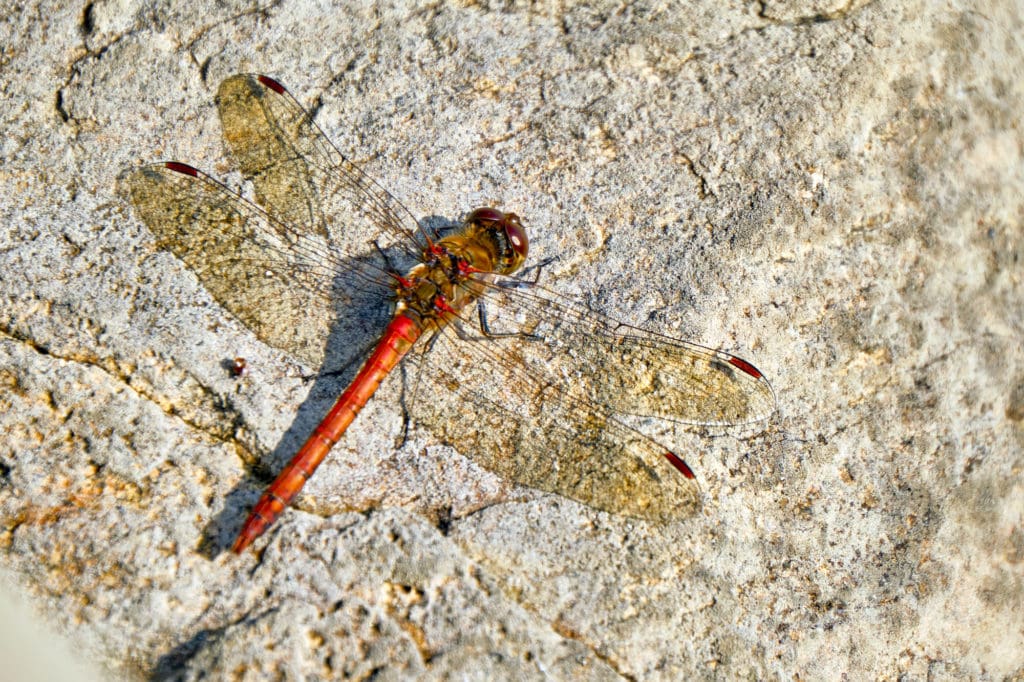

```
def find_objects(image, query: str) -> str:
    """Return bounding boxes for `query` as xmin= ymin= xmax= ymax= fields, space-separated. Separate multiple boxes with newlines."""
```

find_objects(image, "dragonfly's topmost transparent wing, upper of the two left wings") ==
xmin=217 ymin=74 xmax=426 ymax=265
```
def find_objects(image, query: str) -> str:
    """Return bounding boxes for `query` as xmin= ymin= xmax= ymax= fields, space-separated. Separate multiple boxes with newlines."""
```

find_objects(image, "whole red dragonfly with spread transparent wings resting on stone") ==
xmin=125 ymin=74 xmax=775 ymax=553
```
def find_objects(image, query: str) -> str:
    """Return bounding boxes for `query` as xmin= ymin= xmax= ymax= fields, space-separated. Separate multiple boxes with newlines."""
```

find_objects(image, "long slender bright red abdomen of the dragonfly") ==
xmin=231 ymin=314 xmax=423 ymax=554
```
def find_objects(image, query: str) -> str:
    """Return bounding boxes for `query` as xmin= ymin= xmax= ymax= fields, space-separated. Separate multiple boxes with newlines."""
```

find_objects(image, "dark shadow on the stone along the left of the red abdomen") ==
xmin=200 ymin=241 xmax=412 ymax=559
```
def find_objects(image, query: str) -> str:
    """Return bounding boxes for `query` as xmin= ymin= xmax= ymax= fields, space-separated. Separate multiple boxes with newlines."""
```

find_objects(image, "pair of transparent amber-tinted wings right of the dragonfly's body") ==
xmin=403 ymin=276 xmax=775 ymax=521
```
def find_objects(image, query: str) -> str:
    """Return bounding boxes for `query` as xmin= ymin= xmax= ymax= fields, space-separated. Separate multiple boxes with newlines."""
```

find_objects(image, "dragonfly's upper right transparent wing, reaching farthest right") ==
xmin=473 ymin=276 xmax=775 ymax=426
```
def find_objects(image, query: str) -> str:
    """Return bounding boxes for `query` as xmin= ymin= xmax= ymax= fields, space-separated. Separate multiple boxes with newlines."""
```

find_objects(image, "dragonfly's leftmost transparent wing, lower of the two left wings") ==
xmin=122 ymin=162 xmax=385 ymax=368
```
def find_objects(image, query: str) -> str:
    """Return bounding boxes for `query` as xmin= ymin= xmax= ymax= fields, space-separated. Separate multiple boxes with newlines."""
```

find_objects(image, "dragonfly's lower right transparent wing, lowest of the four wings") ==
xmin=412 ymin=319 xmax=699 ymax=522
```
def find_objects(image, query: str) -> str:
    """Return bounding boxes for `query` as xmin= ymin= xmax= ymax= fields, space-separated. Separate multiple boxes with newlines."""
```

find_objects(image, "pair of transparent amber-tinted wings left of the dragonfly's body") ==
xmin=122 ymin=75 xmax=423 ymax=368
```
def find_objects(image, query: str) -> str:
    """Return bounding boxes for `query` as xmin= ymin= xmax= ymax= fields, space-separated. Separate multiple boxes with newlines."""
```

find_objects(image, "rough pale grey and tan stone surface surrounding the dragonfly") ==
xmin=0 ymin=0 xmax=1024 ymax=680
